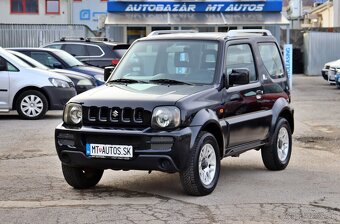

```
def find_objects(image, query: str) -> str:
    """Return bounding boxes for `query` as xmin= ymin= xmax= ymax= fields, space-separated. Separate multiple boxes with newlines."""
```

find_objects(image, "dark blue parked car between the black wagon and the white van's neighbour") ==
xmin=10 ymin=48 xmax=104 ymax=86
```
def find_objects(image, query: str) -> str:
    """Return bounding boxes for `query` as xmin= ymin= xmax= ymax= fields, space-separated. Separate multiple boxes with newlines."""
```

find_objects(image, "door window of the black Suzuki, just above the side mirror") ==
xmin=225 ymin=44 xmax=257 ymax=82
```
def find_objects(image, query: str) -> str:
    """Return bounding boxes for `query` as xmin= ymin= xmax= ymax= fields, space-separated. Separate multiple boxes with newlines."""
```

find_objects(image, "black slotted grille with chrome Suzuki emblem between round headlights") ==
xmin=83 ymin=107 xmax=151 ymax=127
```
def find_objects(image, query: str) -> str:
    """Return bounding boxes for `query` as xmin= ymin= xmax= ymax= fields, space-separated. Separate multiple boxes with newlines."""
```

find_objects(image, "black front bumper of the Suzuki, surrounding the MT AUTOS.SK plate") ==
xmin=55 ymin=124 xmax=196 ymax=172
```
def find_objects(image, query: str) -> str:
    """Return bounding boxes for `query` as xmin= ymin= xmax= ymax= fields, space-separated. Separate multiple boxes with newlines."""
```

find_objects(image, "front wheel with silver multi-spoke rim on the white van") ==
xmin=16 ymin=90 xmax=48 ymax=120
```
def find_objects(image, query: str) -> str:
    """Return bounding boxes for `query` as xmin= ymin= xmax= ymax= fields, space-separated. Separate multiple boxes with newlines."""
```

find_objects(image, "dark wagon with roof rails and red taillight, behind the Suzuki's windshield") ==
xmin=43 ymin=37 xmax=130 ymax=68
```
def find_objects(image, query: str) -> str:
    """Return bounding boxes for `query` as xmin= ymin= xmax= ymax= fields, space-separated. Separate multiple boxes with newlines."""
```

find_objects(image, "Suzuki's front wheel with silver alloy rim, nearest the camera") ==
xmin=180 ymin=132 xmax=221 ymax=196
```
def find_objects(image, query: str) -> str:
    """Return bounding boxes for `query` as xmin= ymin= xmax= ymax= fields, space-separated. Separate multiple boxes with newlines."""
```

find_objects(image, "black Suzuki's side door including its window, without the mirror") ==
xmin=223 ymin=41 xmax=271 ymax=147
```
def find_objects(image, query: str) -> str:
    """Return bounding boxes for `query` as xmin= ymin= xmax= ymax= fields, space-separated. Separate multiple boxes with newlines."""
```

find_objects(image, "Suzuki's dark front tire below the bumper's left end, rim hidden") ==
xmin=62 ymin=164 xmax=104 ymax=189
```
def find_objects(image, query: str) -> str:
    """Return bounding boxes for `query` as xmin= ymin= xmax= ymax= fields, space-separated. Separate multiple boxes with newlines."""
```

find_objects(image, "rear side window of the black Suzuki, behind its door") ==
xmin=259 ymin=43 xmax=284 ymax=79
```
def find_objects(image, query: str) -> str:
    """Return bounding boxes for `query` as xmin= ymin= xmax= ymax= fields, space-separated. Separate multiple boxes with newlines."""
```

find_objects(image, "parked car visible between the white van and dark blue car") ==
xmin=8 ymin=50 xmax=96 ymax=94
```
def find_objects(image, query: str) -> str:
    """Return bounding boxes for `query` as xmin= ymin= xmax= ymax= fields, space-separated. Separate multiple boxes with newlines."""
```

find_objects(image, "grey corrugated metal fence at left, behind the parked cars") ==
xmin=0 ymin=24 xmax=94 ymax=48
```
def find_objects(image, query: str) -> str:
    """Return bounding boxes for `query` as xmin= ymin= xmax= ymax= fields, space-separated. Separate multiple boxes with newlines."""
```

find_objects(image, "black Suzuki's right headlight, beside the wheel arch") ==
xmin=151 ymin=106 xmax=181 ymax=128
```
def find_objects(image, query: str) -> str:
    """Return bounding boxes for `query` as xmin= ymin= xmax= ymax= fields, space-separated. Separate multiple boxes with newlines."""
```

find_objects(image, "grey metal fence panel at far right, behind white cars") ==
xmin=303 ymin=31 xmax=340 ymax=75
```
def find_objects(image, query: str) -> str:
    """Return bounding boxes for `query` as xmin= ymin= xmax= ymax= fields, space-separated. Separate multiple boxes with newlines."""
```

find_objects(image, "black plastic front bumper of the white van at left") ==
xmin=43 ymin=86 xmax=77 ymax=110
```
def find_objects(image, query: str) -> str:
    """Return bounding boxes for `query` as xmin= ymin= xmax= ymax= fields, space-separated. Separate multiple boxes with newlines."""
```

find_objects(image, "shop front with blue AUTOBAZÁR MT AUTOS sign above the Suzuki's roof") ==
xmin=105 ymin=0 xmax=289 ymax=43
